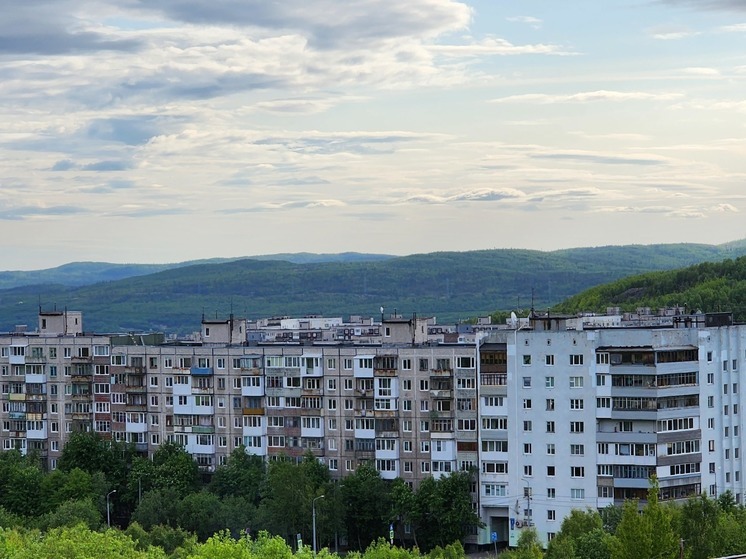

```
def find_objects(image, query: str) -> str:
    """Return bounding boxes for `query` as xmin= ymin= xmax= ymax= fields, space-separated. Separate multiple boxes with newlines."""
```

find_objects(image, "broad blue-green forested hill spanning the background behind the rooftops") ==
xmin=0 ymin=244 xmax=746 ymax=333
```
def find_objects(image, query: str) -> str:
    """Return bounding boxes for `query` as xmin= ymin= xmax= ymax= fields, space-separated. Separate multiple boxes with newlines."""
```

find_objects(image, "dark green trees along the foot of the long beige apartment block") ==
xmin=0 ymin=433 xmax=480 ymax=551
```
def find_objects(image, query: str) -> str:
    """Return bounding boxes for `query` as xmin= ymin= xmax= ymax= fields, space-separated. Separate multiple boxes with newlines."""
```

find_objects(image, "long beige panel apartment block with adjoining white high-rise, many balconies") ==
xmin=0 ymin=311 xmax=746 ymax=545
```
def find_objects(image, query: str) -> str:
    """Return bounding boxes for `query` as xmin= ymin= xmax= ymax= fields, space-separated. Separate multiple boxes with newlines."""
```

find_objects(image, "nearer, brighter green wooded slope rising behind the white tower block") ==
xmin=553 ymin=257 xmax=746 ymax=321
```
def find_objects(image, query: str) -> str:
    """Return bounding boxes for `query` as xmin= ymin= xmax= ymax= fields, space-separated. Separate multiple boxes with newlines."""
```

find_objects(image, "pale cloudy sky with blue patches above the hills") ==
xmin=0 ymin=0 xmax=746 ymax=270
